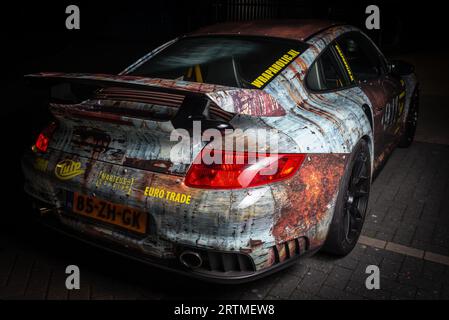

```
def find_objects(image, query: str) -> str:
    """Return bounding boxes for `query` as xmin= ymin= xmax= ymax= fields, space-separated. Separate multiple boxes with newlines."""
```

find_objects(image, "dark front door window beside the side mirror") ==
xmin=336 ymin=33 xmax=384 ymax=81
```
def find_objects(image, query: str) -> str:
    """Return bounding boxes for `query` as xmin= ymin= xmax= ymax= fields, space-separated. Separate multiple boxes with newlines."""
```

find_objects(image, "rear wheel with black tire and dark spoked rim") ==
xmin=323 ymin=140 xmax=371 ymax=256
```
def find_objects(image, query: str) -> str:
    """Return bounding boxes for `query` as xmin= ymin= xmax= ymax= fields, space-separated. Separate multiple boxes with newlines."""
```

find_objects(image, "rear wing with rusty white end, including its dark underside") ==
xmin=25 ymin=73 xmax=285 ymax=117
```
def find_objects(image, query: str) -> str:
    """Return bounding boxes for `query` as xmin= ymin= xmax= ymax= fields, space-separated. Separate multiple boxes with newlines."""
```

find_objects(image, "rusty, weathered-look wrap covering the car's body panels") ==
xmin=22 ymin=22 xmax=416 ymax=280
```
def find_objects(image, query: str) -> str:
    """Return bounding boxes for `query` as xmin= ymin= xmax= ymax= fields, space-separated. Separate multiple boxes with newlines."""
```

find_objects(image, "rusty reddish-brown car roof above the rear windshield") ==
xmin=189 ymin=19 xmax=339 ymax=41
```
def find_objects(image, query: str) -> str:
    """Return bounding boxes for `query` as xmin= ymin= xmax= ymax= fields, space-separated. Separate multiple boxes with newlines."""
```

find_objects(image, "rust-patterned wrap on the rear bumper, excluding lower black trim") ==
xmin=23 ymin=151 xmax=345 ymax=270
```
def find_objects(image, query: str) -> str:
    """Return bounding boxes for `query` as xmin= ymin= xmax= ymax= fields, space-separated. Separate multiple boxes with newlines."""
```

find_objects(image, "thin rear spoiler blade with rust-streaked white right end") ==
xmin=25 ymin=72 xmax=285 ymax=117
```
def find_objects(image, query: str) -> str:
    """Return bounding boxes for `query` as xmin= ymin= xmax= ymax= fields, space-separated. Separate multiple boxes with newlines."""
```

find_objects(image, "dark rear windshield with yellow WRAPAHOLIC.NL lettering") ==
xmin=129 ymin=36 xmax=307 ymax=88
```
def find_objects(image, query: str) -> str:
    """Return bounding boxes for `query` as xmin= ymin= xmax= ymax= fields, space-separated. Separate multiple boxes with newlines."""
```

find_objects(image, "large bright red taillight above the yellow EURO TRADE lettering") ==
xmin=185 ymin=149 xmax=305 ymax=189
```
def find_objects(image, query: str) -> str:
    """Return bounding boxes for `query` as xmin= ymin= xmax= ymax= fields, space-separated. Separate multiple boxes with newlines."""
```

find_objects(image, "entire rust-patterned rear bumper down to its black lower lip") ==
xmin=22 ymin=150 xmax=344 ymax=282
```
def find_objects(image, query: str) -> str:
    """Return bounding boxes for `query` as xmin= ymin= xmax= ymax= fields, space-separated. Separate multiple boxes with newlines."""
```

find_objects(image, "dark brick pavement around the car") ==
xmin=0 ymin=142 xmax=449 ymax=299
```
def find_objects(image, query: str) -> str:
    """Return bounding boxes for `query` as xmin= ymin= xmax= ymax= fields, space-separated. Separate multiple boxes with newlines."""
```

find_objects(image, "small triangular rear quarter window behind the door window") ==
xmin=306 ymin=48 xmax=349 ymax=91
